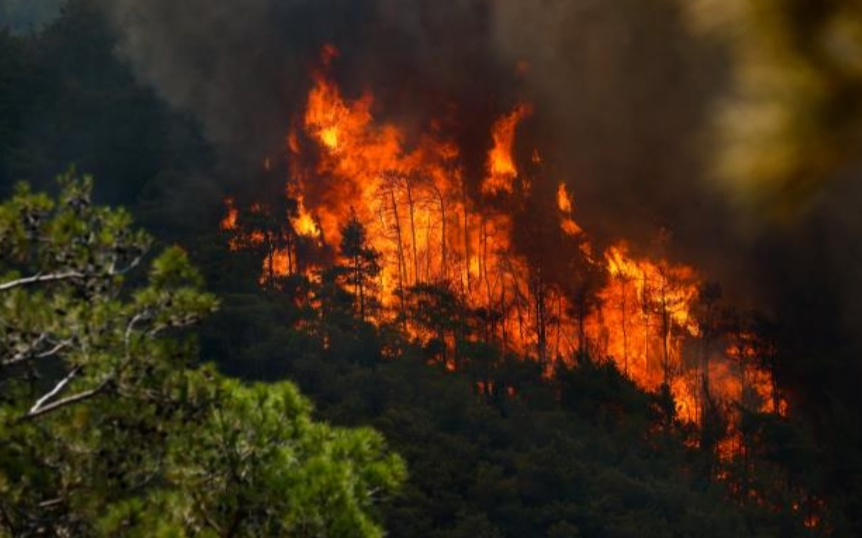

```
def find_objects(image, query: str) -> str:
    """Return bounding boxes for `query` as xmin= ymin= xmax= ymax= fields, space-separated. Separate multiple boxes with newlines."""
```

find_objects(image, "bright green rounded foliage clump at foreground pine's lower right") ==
xmin=158 ymin=376 xmax=404 ymax=537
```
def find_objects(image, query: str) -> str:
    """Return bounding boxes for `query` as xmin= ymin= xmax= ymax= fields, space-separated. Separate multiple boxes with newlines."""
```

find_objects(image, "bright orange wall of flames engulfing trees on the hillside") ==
xmin=222 ymin=46 xmax=786 ymax=428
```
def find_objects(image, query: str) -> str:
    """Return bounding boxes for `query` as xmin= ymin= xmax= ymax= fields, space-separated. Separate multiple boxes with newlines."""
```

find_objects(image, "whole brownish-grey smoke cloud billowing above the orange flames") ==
xmin=105 ymin=0 xmax=726 ymax=244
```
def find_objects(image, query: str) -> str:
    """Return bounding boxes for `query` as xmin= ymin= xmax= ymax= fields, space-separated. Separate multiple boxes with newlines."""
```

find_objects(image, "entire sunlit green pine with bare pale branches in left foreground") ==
xmin=0 ymin=173 xmax=405 ymax=538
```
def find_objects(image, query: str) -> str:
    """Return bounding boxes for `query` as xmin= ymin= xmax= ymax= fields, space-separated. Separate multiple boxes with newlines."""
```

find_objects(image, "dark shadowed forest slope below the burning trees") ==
xmin=204 ymin=275 xmax=832 ymax=538
